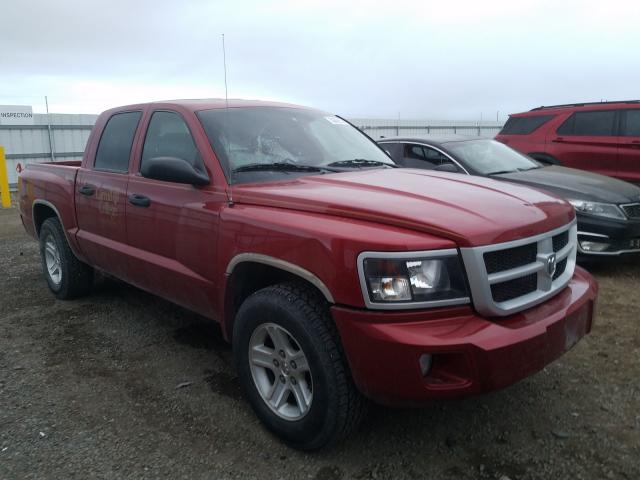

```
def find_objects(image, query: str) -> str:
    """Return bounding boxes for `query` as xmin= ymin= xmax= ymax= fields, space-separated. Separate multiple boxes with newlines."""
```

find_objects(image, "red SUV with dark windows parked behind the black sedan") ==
xmin=496 ymin=100 xmax=640 ymax=183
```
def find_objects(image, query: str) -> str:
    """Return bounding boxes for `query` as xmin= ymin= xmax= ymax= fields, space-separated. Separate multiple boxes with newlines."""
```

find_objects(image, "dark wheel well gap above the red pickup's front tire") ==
xmin=224 ymin=261 xmax=326 ymax=341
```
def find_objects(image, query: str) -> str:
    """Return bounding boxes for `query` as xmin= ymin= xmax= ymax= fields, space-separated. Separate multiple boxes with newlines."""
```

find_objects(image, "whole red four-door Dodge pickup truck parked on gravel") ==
xmin=19 ymin=100 xmax=597 ymax=450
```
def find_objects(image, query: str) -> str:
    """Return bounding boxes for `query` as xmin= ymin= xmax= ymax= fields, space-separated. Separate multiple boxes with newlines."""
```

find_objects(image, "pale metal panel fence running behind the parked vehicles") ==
xmin=0 ymin=114 xmax=503 ymax=188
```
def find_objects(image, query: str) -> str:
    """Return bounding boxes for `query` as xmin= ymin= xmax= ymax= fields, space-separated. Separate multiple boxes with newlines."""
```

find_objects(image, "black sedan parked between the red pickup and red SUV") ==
xmin=379 ymin=135 xmax=640 ymax=256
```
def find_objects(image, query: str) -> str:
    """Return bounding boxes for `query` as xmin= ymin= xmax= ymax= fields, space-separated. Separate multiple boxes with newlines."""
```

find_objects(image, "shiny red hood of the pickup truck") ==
xmin=232 ymin=168 xmax=575 ymax=247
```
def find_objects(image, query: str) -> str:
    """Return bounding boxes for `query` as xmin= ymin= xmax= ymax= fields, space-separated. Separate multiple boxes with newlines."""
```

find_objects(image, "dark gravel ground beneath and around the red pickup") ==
xmin=0 ymin=209 xmax=640 ymax=480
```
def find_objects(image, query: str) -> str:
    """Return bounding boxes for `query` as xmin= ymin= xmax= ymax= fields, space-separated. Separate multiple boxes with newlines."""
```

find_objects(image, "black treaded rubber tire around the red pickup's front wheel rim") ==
xmin=233 ymin=282 xmax=368 ymax=451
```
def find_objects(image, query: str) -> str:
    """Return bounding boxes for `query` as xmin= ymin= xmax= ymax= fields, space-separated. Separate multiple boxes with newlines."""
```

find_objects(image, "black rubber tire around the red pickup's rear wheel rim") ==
xmin=40 ymin=217 xmax=93 ymax=300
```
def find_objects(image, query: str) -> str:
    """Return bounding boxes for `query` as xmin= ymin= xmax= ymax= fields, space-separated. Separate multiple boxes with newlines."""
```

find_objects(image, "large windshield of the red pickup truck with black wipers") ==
xmin=198 ymin=107 xmax=395 ymax=183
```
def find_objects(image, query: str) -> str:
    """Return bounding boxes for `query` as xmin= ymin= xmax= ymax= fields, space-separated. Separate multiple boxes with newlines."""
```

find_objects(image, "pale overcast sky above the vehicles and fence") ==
xmin=0 ymin=0 xmax=640 ymax=120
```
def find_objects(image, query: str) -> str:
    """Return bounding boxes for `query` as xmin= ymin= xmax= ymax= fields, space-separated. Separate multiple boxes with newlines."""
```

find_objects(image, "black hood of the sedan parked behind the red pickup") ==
xmin=494 ymin=166 xmax=640 ymax=204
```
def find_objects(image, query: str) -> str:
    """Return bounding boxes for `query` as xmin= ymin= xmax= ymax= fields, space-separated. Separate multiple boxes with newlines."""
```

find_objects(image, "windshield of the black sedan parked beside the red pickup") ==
xmin=445 ymin=139 xmax=541 ymax=175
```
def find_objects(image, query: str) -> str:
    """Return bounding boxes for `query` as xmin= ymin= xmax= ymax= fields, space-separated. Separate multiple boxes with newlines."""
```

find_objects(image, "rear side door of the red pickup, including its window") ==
xmin=75 ymin=111 xmax=142 ymax=279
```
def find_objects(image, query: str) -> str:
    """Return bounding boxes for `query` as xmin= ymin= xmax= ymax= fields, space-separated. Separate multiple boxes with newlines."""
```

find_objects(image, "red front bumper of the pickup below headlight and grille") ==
xmin=331 ymin=268 xmax=598 ymax=405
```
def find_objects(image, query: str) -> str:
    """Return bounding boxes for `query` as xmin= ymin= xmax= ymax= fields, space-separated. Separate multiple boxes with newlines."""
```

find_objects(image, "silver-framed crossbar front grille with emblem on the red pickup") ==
xmin=460 ymin=221 xmax=577 ymax=316
